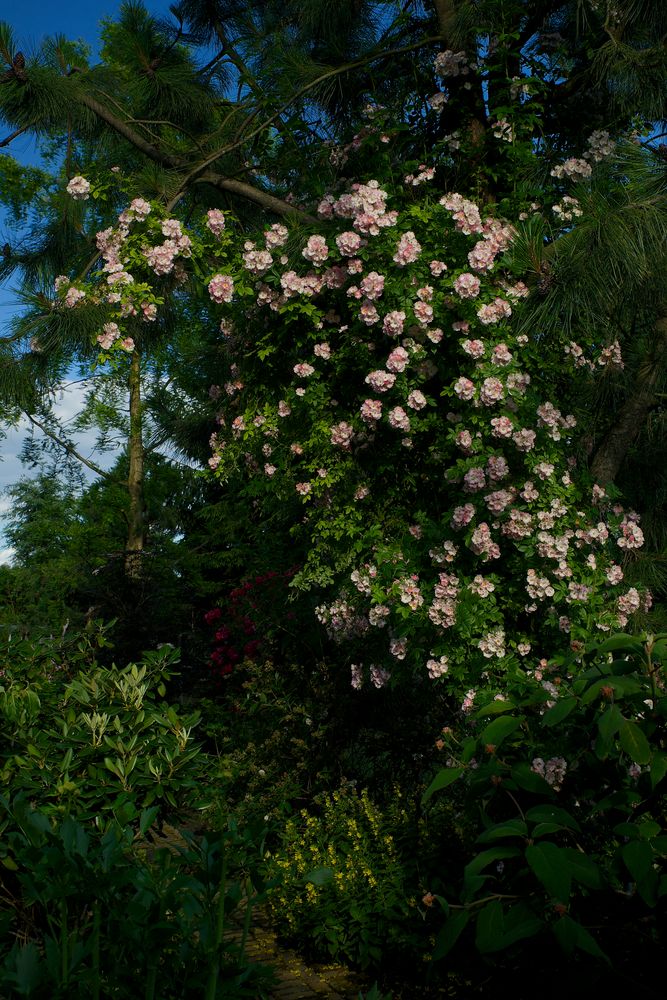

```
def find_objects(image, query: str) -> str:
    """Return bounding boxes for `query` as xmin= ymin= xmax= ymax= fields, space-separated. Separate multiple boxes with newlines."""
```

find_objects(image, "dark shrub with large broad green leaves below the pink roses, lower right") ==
xmin=424 ymin=634 xmax=667 ymax=984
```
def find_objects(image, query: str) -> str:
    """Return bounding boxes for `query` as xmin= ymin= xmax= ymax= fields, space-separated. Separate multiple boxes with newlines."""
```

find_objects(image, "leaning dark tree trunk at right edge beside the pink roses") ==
xmin=591 ymin=315 xmax=667 ymax=486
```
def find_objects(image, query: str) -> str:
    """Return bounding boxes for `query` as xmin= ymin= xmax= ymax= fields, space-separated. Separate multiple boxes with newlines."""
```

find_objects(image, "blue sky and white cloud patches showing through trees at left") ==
xmin=0 ymin=0 xmax=173 ymax=562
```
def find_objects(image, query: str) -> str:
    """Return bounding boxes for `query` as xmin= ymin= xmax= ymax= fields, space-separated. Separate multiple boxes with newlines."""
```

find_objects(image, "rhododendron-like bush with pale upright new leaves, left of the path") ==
xmin=0 ymin=646 xmax=206 ymax=822
